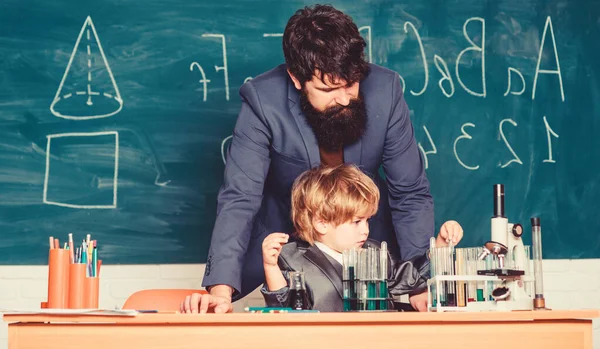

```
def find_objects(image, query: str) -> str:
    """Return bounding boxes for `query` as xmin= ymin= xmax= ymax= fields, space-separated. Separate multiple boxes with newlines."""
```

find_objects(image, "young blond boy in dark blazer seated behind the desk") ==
xmin=261 ymin=165 xmax=463 ymax=312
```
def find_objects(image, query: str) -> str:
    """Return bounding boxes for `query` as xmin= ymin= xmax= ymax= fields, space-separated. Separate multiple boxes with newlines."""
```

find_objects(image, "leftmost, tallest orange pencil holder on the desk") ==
xmin=48 ymin=249 xmax=70 ymax=309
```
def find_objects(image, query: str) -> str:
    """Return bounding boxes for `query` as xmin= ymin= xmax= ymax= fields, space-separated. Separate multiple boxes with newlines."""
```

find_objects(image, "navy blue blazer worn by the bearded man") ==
xmin=202 ymin=64 xmax=434 ymax=300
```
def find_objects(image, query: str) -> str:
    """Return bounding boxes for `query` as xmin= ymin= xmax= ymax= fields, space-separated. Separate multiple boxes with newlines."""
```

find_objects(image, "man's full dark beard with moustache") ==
xmin=300 ymin=89 xmax=367 ymax=152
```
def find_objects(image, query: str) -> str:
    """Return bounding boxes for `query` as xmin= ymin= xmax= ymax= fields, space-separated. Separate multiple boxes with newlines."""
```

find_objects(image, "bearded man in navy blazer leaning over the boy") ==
xmin=181 ymin=5 xmax=434 ymax=313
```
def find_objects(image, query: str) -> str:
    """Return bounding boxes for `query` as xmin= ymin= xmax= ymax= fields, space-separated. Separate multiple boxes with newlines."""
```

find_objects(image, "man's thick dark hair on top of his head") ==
xmin=283 ymin=5 xmax=369 ymax=86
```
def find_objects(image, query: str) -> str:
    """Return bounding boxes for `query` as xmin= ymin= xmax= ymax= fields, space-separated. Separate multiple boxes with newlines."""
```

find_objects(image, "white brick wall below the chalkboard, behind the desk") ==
xmin=0 ymin=259 xmax=600 ymax=349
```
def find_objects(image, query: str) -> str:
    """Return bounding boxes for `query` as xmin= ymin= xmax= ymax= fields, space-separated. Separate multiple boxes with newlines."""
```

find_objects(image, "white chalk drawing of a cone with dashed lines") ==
xmin=50 ymin=16 xmax=123 ymax=120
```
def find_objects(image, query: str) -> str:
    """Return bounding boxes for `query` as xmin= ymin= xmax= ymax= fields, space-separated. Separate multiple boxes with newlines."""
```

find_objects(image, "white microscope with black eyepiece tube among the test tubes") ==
xmin=477 ymin=184 xmax=533 ymax=310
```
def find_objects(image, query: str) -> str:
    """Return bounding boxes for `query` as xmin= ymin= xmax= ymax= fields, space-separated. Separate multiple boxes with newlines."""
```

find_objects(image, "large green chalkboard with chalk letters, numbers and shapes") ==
xmin=0 ymin=0 xmax=600 ymax=264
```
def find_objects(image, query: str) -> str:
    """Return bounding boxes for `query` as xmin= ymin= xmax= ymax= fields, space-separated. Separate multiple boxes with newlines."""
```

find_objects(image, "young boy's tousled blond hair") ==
xmin=292 ymin=164 xmax=379 ymax=244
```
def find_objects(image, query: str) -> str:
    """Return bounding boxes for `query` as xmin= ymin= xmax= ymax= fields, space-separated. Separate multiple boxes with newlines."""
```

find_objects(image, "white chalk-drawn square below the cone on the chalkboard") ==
xmin=44 ymin=131 xmax=119 ymax=209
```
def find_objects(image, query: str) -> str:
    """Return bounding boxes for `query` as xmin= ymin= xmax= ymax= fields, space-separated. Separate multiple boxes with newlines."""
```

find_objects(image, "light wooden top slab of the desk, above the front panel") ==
xmin=3 ymin=310 xmax=600 ymax=326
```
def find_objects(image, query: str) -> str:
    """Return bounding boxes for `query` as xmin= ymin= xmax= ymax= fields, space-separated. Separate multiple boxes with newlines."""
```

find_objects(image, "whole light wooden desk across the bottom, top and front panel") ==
xmin=4 ymin=310 xmax=599 ymax=349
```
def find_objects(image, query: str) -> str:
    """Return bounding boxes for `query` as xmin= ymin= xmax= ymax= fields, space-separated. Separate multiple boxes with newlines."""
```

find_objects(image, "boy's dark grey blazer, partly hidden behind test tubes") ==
xmin=261 ymin=239 xmax=429 ymax=312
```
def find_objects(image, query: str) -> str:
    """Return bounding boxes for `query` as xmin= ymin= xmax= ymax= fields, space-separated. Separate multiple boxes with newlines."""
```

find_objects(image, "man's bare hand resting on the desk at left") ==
xmin=179 ymin=285 xmax=233 ymax=314
